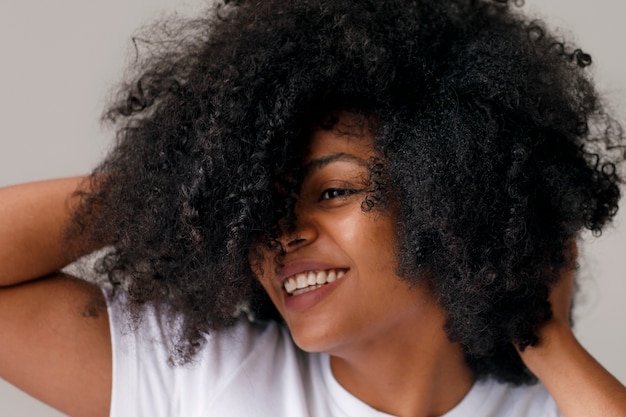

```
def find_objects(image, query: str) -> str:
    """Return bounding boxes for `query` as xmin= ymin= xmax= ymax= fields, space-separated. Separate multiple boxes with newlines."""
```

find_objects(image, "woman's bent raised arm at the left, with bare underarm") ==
xmin=0 ymin=178 xmax=111 ymax=416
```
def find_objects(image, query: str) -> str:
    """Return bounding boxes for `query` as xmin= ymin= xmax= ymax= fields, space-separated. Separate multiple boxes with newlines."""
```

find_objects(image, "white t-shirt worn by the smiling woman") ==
xmin=109 ymin=294 xmax=561 ymax=417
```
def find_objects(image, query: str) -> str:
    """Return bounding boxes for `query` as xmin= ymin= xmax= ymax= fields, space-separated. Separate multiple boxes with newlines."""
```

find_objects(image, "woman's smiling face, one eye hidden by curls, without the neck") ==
xmin=251 ymin=115 xmax=443 ymax=354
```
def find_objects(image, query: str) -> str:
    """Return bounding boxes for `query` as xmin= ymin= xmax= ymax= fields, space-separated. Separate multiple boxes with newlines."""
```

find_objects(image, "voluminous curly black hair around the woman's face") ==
xmin=70 ymin=0 xmax=624 ymax=383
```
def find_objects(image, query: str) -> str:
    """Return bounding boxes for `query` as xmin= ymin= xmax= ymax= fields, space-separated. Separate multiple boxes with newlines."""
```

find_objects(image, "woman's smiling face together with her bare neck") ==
xmin=254 ymin=113 xmax=473 ymax=415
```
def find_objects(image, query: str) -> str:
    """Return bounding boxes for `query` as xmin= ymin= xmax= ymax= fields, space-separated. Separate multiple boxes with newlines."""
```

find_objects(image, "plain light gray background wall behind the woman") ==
xmin=0 ymin=0 xmax=626 ymax=417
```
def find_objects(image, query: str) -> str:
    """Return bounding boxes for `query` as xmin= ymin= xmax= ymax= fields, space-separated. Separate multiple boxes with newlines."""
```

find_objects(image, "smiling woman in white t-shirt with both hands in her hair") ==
xmin=0 ymin=0 xmax=626 ymax=416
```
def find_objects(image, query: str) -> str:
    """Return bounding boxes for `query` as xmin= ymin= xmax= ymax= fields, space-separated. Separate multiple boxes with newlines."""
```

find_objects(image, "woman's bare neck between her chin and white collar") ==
xmin=331 ymin=302 xmax=474 ymax=417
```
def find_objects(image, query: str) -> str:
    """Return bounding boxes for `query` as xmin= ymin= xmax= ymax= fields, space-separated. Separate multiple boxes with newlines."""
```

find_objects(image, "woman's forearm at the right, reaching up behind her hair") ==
xmin=520 ymin=244 xmax=626 ymax=417
